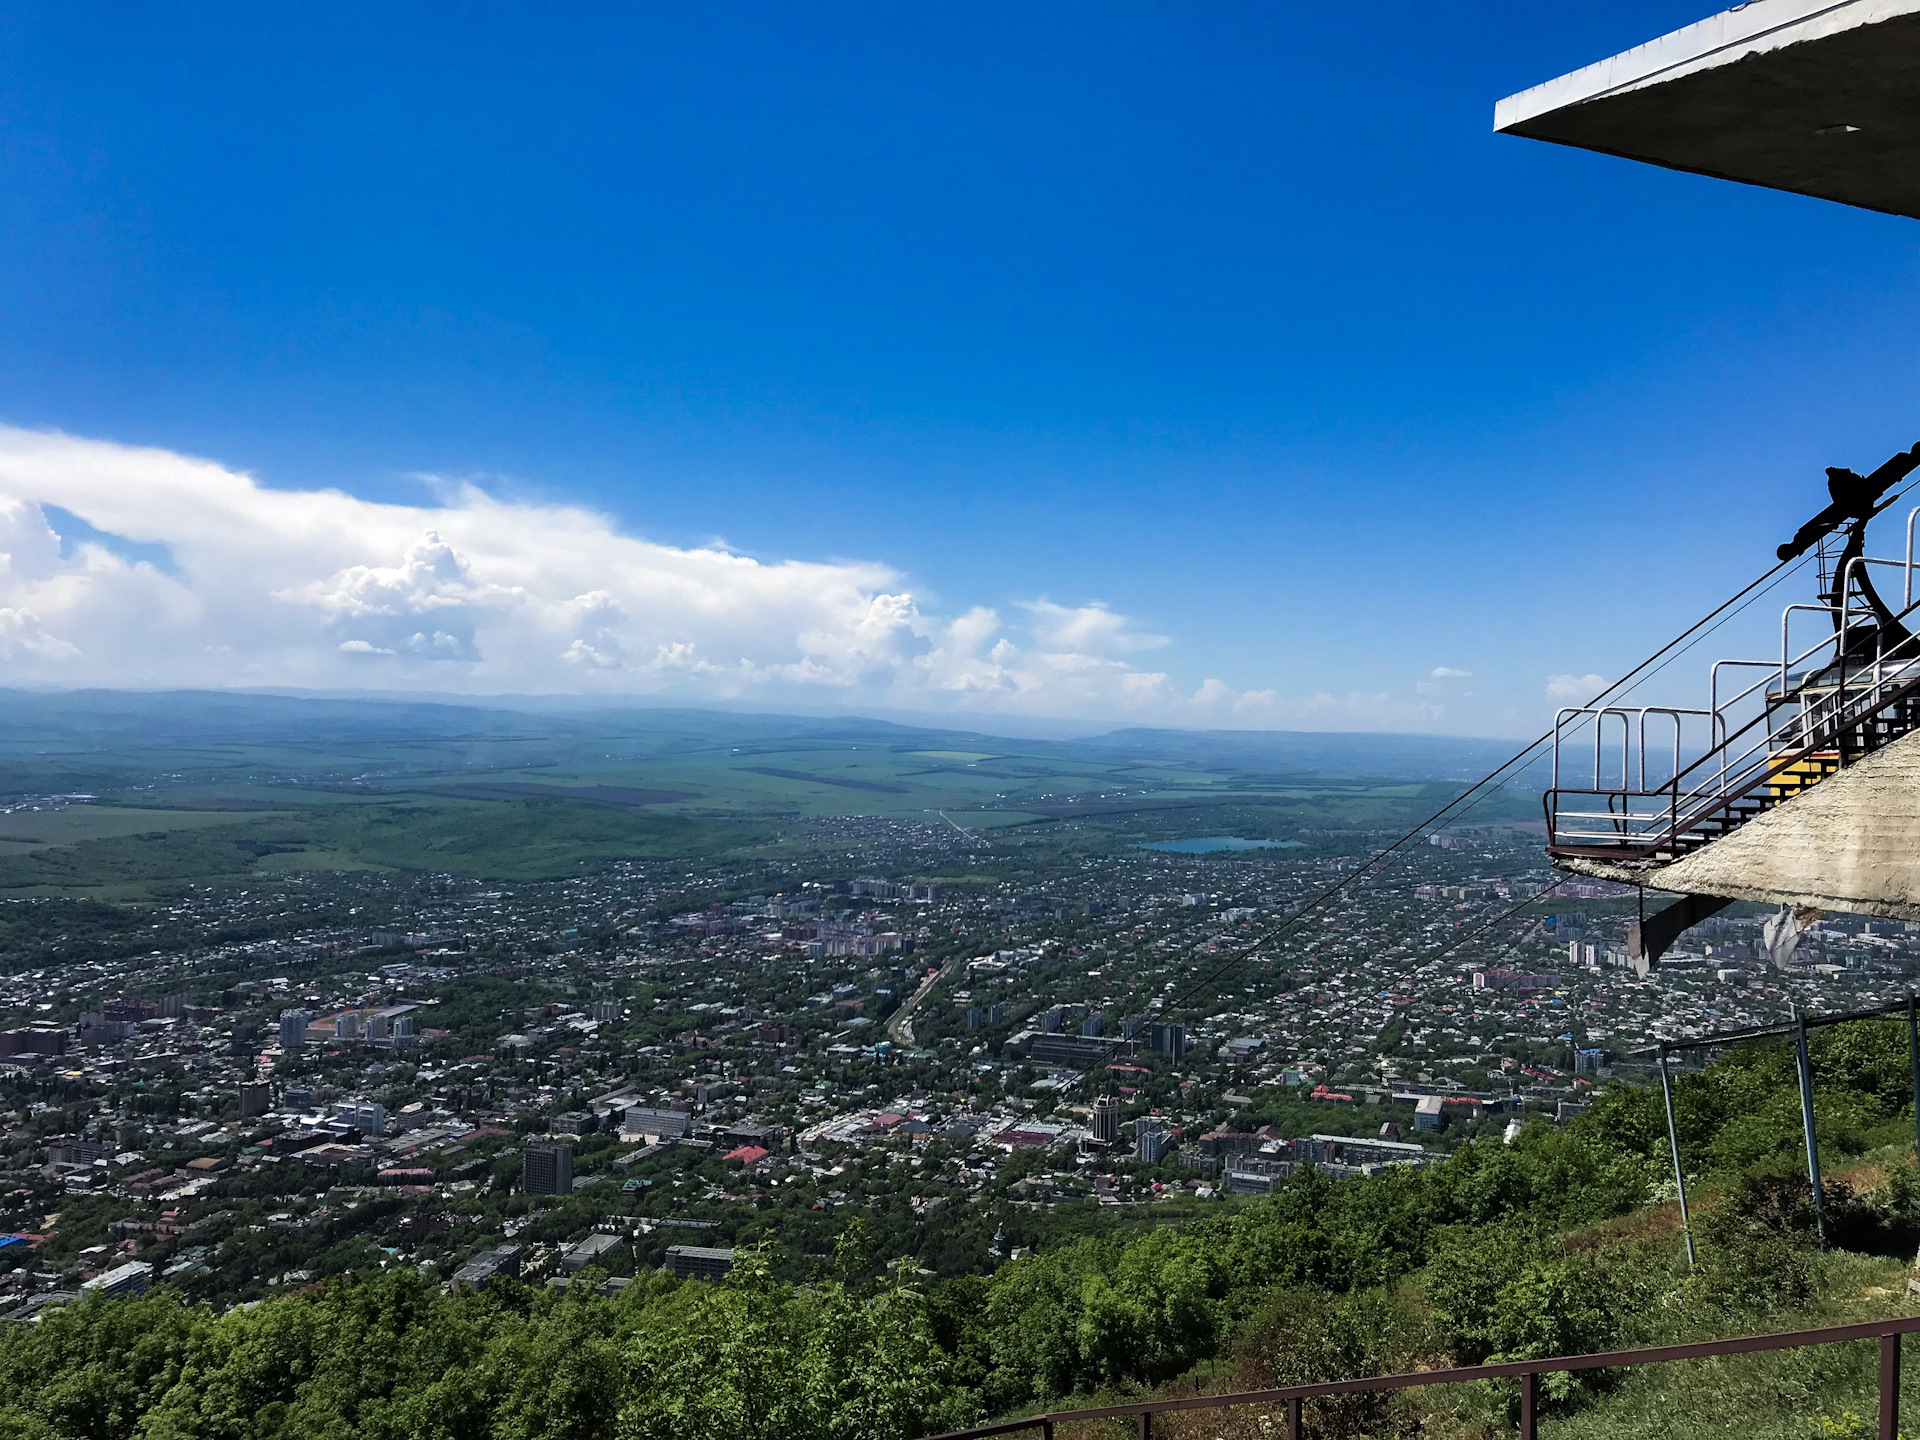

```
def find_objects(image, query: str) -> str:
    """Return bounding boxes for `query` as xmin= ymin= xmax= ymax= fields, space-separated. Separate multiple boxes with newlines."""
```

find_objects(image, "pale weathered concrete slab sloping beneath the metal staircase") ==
xmin=1559 ymin=730 xmax=1920 ymax=920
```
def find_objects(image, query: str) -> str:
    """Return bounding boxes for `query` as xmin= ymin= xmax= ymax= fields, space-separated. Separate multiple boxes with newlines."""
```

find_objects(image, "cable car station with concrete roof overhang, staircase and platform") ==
xmin=1494 ymin=0 xmax=1920 ymax=972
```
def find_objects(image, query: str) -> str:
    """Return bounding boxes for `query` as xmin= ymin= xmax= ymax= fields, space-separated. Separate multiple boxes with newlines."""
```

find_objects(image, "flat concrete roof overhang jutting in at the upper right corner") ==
xmin=1494 ymin=0 xmax=1920 ymax=219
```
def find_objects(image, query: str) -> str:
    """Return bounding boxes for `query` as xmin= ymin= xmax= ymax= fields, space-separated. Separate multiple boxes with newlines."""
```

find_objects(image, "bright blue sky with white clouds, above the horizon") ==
xmin=0 ymin=4 xmax=1920 ymax=733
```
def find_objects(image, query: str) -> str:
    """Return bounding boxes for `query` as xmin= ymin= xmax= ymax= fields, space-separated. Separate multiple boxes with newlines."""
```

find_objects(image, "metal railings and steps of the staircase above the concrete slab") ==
xmin=1546 ymin=507 xmax=1920 ymax=858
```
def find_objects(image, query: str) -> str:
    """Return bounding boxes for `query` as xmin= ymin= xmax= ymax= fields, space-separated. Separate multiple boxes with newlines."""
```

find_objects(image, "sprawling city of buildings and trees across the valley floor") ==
xmin=0 ymin=814 xmax=1920 ymax=1321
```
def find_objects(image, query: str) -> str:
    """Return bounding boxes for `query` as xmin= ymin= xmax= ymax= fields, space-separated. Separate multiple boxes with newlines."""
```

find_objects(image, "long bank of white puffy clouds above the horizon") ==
xmin=0 ymin=426 xmax=1465 ymax=730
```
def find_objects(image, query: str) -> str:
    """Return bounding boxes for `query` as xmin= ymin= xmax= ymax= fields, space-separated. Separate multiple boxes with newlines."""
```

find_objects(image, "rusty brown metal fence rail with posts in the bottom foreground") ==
xmin=913 ymin=1315 xmax=1920 ymax=1440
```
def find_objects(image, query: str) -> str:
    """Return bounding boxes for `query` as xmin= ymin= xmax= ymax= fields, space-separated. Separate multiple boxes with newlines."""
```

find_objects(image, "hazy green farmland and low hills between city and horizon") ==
xmin=0 ymin=691 xmax=1524 ymax=899
